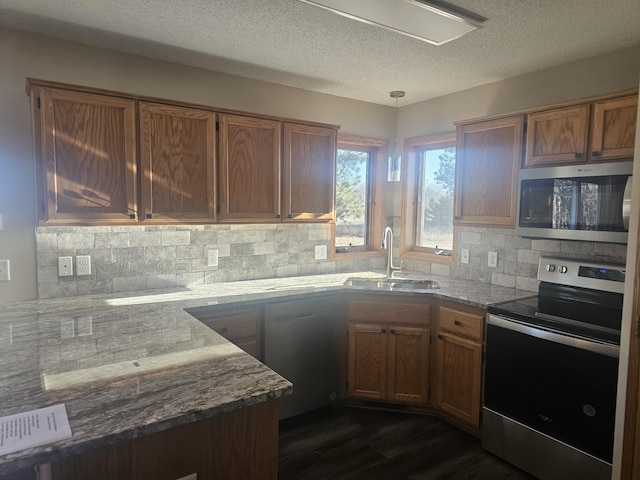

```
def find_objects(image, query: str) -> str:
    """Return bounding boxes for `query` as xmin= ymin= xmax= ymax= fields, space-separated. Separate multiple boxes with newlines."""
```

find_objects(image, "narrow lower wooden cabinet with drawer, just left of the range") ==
xmin=433 ymin=304 xmax=484 ymax=428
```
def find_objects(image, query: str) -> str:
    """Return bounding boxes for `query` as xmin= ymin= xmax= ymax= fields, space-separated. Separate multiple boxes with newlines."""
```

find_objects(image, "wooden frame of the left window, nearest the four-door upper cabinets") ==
xmin=331 ymin=134 xmax=388 ymax=260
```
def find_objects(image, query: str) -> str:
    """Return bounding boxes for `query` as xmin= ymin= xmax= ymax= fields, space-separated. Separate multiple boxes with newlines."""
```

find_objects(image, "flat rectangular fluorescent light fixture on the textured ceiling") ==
xmin=300 ymin=0 xmax=486 ymax=45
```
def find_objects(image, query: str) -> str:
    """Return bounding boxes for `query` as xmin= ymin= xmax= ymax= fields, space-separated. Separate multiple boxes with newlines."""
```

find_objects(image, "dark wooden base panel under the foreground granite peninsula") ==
xmin=39 ymin=400 xmax=278 ymax=480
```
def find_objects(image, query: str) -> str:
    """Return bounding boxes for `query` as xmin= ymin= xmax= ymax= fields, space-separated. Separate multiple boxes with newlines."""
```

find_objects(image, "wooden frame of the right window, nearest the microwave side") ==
xmin=400 ymin=131 xmax=458 ymax=265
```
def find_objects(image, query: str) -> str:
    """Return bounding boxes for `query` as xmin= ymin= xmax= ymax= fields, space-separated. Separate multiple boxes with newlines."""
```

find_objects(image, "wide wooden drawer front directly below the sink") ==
xmin=349 ymin=298 xmax=431 ymax=325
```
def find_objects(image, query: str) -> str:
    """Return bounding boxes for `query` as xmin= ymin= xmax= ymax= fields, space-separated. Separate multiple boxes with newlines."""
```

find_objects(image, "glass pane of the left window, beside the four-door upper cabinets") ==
xmin=336 ymin=149 xmax=371 ymax=247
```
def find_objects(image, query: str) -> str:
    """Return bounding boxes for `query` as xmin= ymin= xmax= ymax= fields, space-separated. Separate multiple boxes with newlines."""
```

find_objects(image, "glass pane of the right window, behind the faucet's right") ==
xmin=416 ymin=147 xmax=456 ymax=250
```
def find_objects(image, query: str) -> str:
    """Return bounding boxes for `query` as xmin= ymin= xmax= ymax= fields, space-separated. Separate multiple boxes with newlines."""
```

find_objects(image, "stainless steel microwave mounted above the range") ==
xmin=516 ymin=162 xmax=633 ymax=243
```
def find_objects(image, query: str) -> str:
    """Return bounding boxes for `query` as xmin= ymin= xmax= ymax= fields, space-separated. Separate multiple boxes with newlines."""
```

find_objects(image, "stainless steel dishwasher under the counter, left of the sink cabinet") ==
xmin=263 ymin=296 xmax=340 ymax=419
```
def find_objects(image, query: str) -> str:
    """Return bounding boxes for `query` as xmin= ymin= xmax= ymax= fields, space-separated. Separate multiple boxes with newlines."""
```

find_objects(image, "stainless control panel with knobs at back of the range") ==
xmin=538 ymin=257 xmax=626 ymax=293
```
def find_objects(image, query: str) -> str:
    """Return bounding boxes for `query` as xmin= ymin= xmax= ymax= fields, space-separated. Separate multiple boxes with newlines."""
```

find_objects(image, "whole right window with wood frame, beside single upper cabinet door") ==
xmin=400 ymin=132 xmax=456 ymax=263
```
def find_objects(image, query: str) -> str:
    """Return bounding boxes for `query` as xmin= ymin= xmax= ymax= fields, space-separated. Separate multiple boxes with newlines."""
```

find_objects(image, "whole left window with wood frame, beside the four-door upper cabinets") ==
xmin=333 ymin=135 xmax=387 ymax=258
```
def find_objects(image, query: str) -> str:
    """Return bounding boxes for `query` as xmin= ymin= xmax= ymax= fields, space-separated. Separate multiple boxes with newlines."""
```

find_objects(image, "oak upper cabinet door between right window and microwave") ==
xmin=454 ymin=116 xmax=524 ymax=227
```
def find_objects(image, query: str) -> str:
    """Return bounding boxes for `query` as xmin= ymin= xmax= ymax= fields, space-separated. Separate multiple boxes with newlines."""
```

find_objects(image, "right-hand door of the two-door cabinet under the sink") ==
xmin=387 ymin=326 xmax=429 ymax=405
